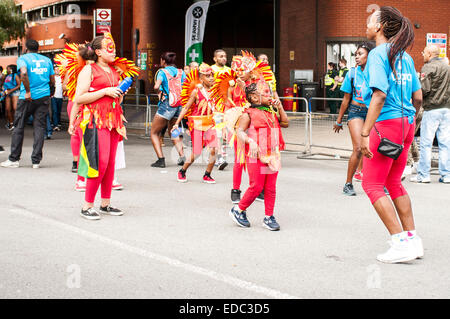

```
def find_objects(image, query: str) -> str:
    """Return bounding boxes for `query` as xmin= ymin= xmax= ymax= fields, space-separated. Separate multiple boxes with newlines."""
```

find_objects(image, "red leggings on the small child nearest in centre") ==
xmin=239 ymin=159 xmax=278 ymax=216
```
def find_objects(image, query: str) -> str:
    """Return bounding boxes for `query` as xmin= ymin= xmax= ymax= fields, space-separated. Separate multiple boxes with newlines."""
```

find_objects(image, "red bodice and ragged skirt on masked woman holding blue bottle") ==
xmin=80 ymin=63 xmax=125 ymax=136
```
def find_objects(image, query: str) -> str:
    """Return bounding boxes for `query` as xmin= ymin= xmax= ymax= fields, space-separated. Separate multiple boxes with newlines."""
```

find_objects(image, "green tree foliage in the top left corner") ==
xmin=0 ymin=0 xmax=27 ymax=46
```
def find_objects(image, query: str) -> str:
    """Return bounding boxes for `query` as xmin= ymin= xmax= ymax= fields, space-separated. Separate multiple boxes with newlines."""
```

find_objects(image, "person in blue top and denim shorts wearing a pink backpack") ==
xmin=150 ymin=52 xmax=186 ymax=168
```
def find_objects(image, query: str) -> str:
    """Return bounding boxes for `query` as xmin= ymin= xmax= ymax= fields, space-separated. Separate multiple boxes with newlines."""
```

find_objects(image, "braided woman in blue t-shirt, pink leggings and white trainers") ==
xmin=361 ymin=6 xmax=423 ymax=263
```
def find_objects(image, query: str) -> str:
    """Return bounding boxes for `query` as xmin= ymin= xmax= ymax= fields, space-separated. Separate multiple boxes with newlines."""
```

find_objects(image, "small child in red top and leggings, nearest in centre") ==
xmin=230 ymin=82 xmax=289 ymax=230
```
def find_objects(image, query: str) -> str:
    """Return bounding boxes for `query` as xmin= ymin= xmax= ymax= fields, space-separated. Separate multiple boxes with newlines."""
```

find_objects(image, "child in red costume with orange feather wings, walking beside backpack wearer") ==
xmin=171 ymin=63 xmax=217 ymax=184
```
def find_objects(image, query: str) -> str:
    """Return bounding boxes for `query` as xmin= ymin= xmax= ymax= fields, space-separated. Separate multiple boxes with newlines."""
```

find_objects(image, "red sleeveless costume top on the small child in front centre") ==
xmin=245 ymin=107 xmax=285 ymax=155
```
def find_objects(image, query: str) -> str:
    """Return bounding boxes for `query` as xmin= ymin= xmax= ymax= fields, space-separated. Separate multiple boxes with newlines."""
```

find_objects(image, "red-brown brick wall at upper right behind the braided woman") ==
xmin=279 ymin=0 xmax=450 ymax=94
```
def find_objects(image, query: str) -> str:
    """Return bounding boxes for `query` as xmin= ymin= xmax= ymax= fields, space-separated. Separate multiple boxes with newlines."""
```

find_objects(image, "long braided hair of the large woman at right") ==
xmin=377 ymin=6 xmax=415 ymax=74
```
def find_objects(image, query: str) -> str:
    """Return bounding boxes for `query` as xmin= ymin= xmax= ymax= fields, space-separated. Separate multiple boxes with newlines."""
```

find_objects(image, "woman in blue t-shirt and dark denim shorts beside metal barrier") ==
xmin=333 ymin=43 xmax=373 ymax=196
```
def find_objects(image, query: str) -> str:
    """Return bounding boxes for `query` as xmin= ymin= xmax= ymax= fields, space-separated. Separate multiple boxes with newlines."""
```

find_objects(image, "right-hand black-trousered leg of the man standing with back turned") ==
xmin=31 ymin=97 xmax=50 ymax=164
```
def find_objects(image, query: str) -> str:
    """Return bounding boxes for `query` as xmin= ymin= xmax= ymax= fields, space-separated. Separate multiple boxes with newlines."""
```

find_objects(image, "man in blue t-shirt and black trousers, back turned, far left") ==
xmin=1 ymin=39 xmax=55 ymax=168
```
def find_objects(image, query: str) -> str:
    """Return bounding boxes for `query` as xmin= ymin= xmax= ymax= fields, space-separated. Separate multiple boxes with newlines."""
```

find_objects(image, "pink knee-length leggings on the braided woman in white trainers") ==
xmin=362 ymin=117 xmax=415 ymax=204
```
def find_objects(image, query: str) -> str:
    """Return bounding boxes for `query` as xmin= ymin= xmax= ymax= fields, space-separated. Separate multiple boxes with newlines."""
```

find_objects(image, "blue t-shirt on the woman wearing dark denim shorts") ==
xmin=341 ymin=66 xmax=372 ymax=106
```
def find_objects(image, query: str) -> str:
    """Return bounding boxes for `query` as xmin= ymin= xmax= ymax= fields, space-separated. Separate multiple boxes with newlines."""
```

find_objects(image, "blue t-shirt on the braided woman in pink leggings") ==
xmin=364 ymin=43 xmax=421 ymax=122
